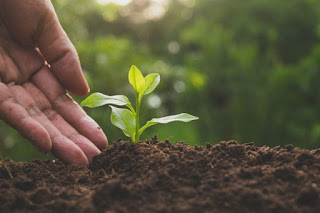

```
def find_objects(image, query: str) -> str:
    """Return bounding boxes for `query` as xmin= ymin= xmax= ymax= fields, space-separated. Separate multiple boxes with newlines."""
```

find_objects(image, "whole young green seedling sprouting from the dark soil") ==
xmin=81 ymin=65 xmax=199 ymax=143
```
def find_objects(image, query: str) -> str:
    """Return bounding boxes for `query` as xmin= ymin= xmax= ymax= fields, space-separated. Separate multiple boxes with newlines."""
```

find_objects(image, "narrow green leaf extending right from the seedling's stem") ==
xmin=139 ymin=113 xmax=199 ymax=134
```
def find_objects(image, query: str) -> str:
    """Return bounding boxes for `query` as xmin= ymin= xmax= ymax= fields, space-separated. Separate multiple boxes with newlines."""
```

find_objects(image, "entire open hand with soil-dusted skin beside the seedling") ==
xmin=0 ymin=0 xmax=108 ymax=165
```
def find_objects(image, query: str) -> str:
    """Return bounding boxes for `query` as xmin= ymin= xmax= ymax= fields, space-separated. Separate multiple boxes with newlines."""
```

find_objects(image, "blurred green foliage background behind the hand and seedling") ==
xmin=0 ymin=0 xmax=320 ymax=160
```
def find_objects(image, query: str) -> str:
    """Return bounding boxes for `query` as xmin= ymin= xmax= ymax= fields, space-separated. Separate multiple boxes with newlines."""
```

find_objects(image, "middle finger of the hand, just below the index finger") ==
xmin=23 ymin=83 xmax=100 ymax=162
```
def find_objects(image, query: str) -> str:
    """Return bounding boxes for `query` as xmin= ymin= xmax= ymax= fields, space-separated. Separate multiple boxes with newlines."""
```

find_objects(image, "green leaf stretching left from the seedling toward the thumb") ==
xmin=80 ymin=92 xmax=131 ymax=108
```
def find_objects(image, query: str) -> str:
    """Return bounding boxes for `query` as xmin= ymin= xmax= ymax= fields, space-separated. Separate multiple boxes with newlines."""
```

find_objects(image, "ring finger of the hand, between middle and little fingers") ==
xmin=9 ymin=85 xmax=88 ymax=166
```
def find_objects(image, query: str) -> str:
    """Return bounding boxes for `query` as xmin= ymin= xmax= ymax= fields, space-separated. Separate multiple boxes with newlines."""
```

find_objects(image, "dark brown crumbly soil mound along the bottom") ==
xmin=0 ymin=138 xmax=320 ymax=213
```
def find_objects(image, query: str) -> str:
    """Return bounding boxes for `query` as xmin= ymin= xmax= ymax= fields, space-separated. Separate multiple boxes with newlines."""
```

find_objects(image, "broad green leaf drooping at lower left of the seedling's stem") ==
xmin=110 ymin=106 xmax=136 ymax=140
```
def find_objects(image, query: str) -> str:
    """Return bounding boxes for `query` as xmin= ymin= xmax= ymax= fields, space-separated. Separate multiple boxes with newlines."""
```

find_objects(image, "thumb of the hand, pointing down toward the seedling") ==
xmin=36 ymin=1 xmax=89 ymax=96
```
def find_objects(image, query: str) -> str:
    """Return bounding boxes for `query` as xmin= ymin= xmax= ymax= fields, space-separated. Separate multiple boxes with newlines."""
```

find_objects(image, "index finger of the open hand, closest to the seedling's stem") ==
xmin=32 ymin=68 xmax=108 ymax=150
